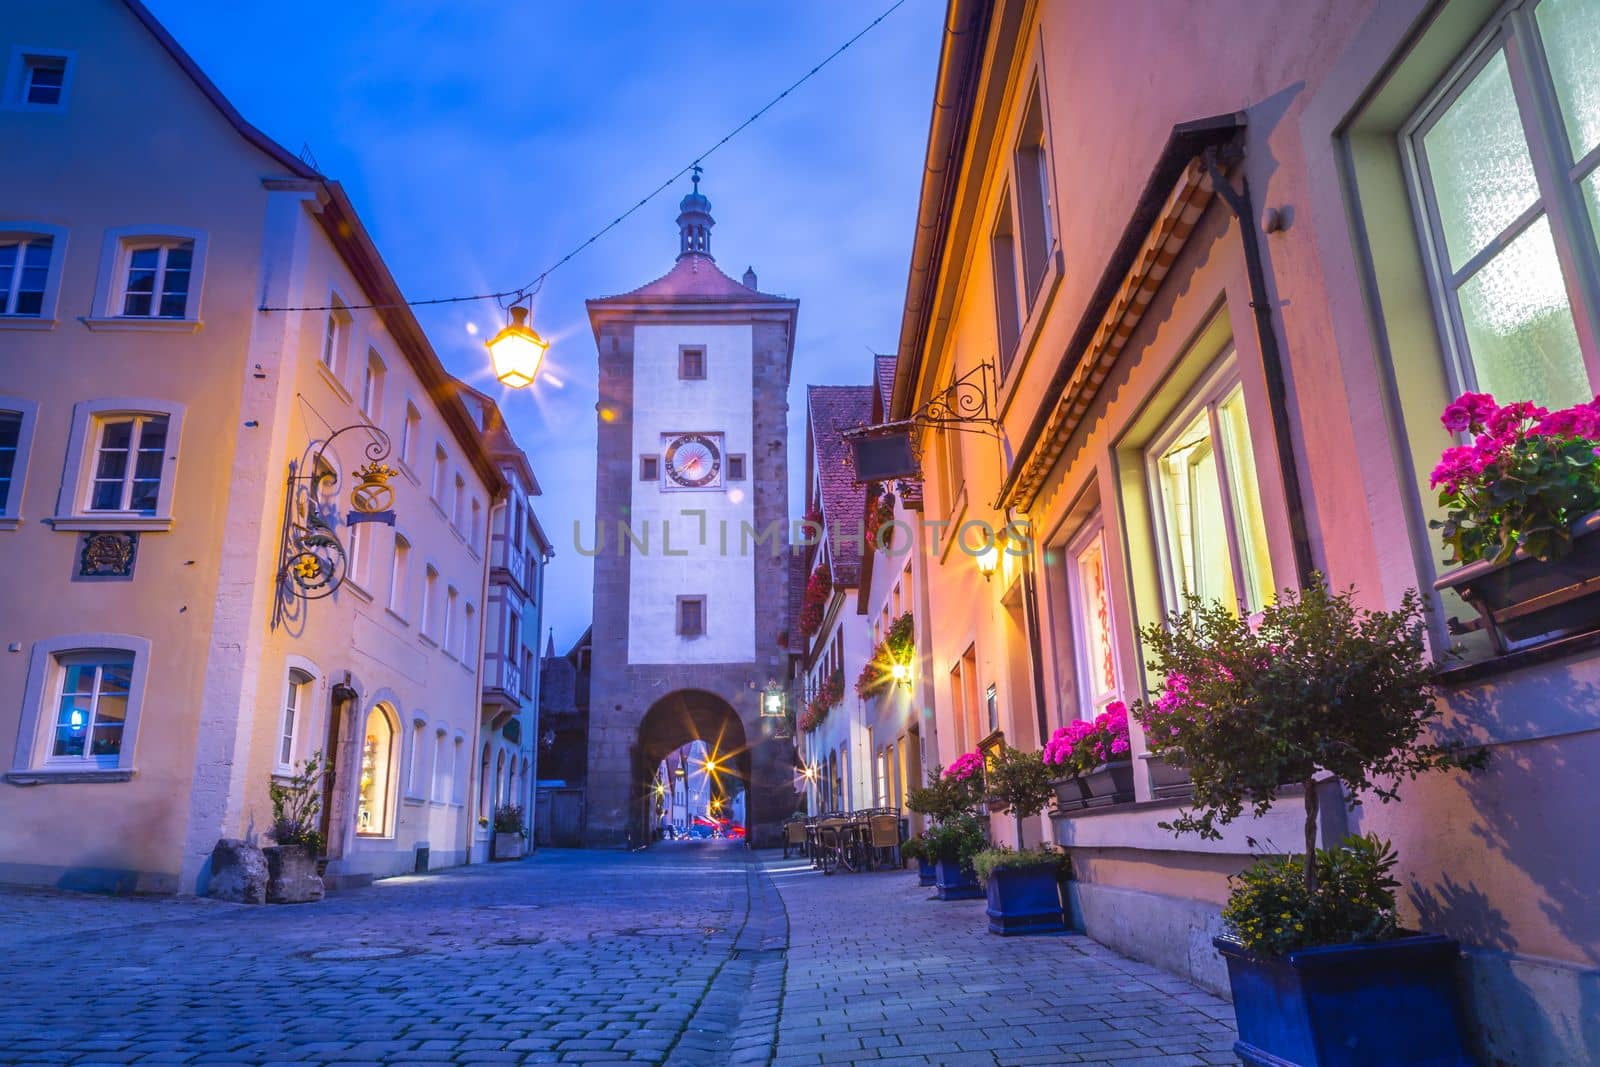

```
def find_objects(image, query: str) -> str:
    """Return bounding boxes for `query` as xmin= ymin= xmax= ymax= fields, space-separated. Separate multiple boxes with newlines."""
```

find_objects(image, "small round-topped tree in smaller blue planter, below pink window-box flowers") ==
xmin=973 ymin=745 xmax=1066 ymax=934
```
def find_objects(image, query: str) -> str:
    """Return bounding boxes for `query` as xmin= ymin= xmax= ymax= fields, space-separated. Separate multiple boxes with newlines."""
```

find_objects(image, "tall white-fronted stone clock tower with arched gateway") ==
xmin=581 ymin=166 xmax=800 ymax=845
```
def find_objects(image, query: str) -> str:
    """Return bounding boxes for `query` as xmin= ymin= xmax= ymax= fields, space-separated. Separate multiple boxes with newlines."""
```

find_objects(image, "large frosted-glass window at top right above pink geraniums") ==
xmin=1403 ymin=0 xmax=1600 ymax=408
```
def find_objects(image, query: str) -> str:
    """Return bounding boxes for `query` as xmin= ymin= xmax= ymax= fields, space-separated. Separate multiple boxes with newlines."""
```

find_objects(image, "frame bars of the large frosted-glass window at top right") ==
xmin=1395 ymin=0 xmax=1600 ymax=400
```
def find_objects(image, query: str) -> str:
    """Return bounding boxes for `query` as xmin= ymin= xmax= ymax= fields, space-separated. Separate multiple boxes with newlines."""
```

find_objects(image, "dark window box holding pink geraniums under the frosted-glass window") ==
xmin=1434 ymin=512 xmax=1600 ymax=653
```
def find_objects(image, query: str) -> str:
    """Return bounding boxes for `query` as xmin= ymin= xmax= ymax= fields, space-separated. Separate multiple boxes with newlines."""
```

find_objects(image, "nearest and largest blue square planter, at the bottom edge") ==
xmin=1211 ymin=934 xmax=1474 ymax=1067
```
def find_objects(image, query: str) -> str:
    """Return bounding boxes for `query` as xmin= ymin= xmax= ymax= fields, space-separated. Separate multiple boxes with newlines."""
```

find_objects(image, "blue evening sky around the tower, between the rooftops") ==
xmin=147 ymin=0 xmax=944 ymax=646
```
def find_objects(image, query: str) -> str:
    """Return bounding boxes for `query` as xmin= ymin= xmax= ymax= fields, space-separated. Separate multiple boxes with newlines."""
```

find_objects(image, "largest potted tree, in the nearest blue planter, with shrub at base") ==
xmin=1134 ymin=576 xmax=1482 ymax=1067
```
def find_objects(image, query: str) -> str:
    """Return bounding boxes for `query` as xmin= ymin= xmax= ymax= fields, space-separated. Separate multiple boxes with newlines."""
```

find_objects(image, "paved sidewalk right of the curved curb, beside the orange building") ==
xmin=766 ymin=861 xmax=1238 ymax=1067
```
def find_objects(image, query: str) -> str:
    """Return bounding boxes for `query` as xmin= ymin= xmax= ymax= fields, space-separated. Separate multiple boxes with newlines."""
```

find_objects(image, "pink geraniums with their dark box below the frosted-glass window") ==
xmin=1429 ymin=394 xmax=1600 ymax=653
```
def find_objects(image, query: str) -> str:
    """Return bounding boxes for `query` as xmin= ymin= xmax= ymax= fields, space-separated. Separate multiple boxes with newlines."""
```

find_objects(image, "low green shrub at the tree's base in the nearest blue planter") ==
xmin=1222 ymin=833 xmax=1400 ymax=957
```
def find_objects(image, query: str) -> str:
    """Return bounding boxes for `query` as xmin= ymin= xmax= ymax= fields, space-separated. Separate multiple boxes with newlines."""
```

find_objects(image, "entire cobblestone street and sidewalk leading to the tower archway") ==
xmin=0 ymin=845 xmax=1232 ymax=1064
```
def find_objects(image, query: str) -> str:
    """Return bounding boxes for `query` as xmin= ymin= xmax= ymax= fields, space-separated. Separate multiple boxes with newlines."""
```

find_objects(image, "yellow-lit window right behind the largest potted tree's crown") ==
xmin=1149 ymin=364 xmax=1274 ymax=614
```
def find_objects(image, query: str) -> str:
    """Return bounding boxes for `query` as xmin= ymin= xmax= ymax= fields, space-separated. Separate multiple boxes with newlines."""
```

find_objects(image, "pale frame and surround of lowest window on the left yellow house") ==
xmin=6 ymin=633 xmax=150 ymax=784
